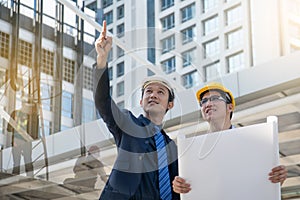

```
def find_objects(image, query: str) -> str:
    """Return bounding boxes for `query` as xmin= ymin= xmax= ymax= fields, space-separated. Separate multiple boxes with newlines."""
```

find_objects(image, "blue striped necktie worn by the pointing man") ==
xmin=154 ymin=127 xmax=172 ymax=200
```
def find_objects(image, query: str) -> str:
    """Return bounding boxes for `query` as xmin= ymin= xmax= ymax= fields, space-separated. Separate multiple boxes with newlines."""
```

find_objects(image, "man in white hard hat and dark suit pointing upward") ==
xmin=94 ymin=21 xmax=180 ymax=200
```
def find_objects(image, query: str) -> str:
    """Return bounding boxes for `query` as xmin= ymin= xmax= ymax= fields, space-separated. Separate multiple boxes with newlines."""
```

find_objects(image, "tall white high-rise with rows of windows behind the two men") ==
xmin=86 ymin=0 xmax=299 ymax=106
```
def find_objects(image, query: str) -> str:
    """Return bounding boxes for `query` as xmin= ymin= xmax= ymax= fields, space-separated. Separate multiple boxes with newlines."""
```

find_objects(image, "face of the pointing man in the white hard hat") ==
xmin=140 ymin=83 xmax=173 ymax=115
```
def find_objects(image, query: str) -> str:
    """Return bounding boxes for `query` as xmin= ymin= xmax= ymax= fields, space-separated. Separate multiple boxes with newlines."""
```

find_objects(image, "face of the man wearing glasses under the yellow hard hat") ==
xmin=201 ymin=91 xmax=232 ymax=122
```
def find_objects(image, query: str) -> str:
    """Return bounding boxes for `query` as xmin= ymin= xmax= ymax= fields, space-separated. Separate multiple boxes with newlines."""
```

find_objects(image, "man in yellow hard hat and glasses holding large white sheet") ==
xmin=173 ymin=82 xmax=287 ymax=193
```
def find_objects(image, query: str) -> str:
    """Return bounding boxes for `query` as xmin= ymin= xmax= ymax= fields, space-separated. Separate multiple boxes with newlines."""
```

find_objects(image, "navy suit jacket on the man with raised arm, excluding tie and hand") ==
xmin=93 ymin=67 xmax=180 ymax=200
